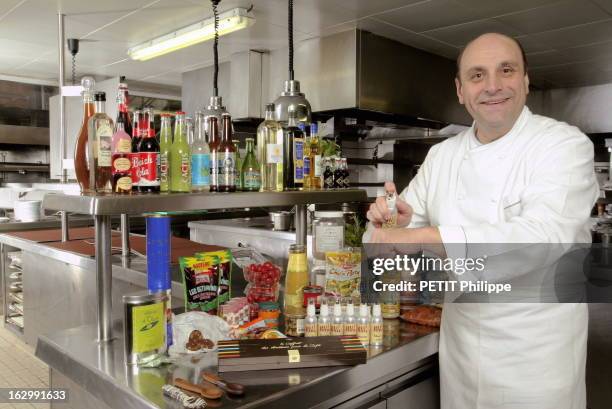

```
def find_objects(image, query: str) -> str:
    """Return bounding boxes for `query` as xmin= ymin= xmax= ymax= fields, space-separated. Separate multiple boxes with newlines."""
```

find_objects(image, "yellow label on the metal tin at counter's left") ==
xmin=132 ymin=302 xmax=166 ymax=354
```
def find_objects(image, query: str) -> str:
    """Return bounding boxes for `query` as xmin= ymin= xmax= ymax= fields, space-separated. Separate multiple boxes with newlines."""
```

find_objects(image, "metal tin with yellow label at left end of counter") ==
xmin=123 ymin=291 xmax=168 ymax=365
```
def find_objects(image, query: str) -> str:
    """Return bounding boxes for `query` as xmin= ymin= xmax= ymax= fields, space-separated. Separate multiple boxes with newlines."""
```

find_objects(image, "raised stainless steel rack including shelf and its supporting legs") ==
xmin=43 ymin=189 xmax=367 ymax=342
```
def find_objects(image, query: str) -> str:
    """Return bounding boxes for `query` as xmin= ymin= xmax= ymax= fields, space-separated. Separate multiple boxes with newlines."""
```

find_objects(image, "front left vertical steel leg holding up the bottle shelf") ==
xmin=96 ymin=216 xmax=113 ymax=342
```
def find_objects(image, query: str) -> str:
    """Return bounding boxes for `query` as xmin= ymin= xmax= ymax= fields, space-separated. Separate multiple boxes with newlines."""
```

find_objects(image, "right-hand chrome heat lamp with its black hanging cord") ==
xmin=274 ymin=0 xmax=312 ymax=123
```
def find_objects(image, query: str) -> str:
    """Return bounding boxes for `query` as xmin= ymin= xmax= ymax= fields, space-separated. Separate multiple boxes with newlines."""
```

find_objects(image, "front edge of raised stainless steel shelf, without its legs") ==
xmin=43 ymin=189 xmax=368 ymax=216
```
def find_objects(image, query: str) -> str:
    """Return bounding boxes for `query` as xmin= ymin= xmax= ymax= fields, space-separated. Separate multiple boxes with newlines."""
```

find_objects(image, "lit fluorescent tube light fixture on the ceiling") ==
xmin=128 ymin=8 xmax=255 ymax=61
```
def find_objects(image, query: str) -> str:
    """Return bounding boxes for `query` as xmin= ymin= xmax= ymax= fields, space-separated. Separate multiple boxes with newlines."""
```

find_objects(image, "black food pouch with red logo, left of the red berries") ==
xmin=179 ymin=257 xmax=219 ymax=314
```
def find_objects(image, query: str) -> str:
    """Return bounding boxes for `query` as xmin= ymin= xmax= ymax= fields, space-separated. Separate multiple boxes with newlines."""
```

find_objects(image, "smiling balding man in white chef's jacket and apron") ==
xmin=368 ymin=33 xmax=598 ymax=409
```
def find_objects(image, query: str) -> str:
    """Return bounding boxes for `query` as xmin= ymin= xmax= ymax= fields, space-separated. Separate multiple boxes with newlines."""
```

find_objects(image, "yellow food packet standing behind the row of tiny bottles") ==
xmin=325 ymin=249 xmax=361 ymax=297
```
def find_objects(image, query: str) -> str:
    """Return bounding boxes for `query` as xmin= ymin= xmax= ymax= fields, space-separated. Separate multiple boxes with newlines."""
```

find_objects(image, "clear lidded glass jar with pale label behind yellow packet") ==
xmin=312 ymin=211 xmax=344 ymax=260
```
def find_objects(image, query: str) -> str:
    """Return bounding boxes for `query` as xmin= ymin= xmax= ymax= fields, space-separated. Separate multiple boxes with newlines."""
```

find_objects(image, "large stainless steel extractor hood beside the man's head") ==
xmin=296 ymin=30 xmax=471 ymax=125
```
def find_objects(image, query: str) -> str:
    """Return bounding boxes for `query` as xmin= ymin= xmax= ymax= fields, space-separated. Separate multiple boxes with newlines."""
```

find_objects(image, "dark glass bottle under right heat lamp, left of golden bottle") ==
xmin=283 ymin=111 xmax=304 ymax=190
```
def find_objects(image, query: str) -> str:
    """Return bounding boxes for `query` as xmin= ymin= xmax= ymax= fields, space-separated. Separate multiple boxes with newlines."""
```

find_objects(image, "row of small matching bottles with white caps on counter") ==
xmin=304 ymin=299 xmax=383 ymax=346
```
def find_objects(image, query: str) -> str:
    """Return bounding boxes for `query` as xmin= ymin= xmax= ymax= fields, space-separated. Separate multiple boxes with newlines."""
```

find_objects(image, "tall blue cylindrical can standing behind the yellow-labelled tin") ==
xmin=146 ymin=214 xmax=172 ymax=292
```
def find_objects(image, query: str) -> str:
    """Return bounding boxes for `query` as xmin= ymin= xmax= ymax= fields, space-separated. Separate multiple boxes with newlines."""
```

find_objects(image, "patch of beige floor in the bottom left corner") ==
xmin=0 ymin=316 xmax=49 ymax=409
